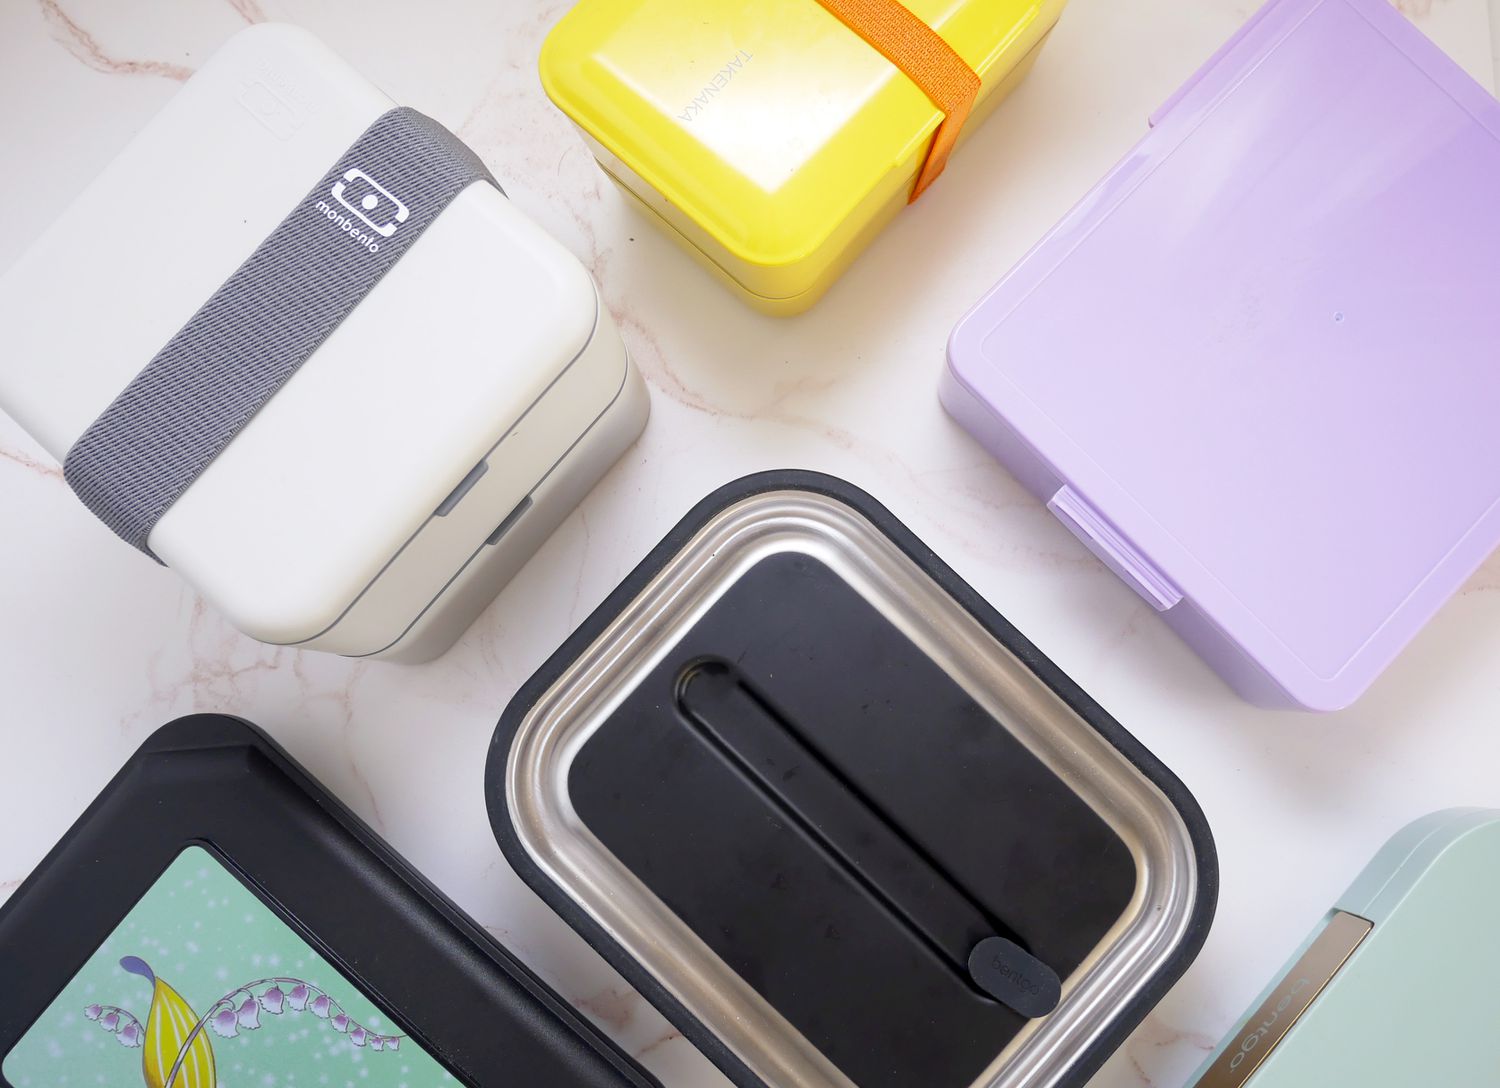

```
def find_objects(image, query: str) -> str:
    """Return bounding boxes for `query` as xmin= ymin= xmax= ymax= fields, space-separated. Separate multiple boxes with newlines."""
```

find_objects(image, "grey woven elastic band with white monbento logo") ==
xmin=63 ymin=108 xmax=498 ymax=554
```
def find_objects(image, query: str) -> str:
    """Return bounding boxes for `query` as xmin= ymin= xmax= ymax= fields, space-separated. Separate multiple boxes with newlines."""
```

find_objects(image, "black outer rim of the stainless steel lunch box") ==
xmin=485 ymin=470 xmax=1220 ymax=1088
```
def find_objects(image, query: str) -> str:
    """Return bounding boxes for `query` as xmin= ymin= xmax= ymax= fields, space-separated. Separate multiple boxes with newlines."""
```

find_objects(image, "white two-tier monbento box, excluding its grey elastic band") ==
xmin=0 ymin=26 xmax=648 ymax=660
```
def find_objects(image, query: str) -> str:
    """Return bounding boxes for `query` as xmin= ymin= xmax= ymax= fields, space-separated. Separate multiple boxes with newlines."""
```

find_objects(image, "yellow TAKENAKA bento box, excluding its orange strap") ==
xmin=542 ymin=0 xmax=1065 ymax=314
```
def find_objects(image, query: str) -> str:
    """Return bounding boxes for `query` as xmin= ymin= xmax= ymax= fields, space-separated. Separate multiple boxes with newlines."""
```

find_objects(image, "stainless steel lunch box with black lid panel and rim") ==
xmin=486 ymin=473 xmax=1217 ymax=1088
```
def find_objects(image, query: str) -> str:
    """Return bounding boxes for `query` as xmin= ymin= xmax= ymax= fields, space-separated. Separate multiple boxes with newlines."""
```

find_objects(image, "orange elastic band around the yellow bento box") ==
xmin=818 ymin=0 xmax=980 ymax=201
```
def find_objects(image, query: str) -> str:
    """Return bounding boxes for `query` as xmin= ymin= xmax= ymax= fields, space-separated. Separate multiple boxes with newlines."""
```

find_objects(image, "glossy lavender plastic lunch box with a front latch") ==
xmin=942 ymin=0 xmax=1500 ymax=710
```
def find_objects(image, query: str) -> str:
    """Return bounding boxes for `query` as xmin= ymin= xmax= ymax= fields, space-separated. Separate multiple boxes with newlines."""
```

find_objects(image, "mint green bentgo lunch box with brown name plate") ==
xmin=1190 ymin=809 xmax=1500 ymax=1088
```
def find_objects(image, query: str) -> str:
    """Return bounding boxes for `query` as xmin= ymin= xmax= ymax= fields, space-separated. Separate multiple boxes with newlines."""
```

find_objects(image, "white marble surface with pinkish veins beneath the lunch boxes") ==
xmin=0 ymin=0 xmax=1500 ymax=1088
